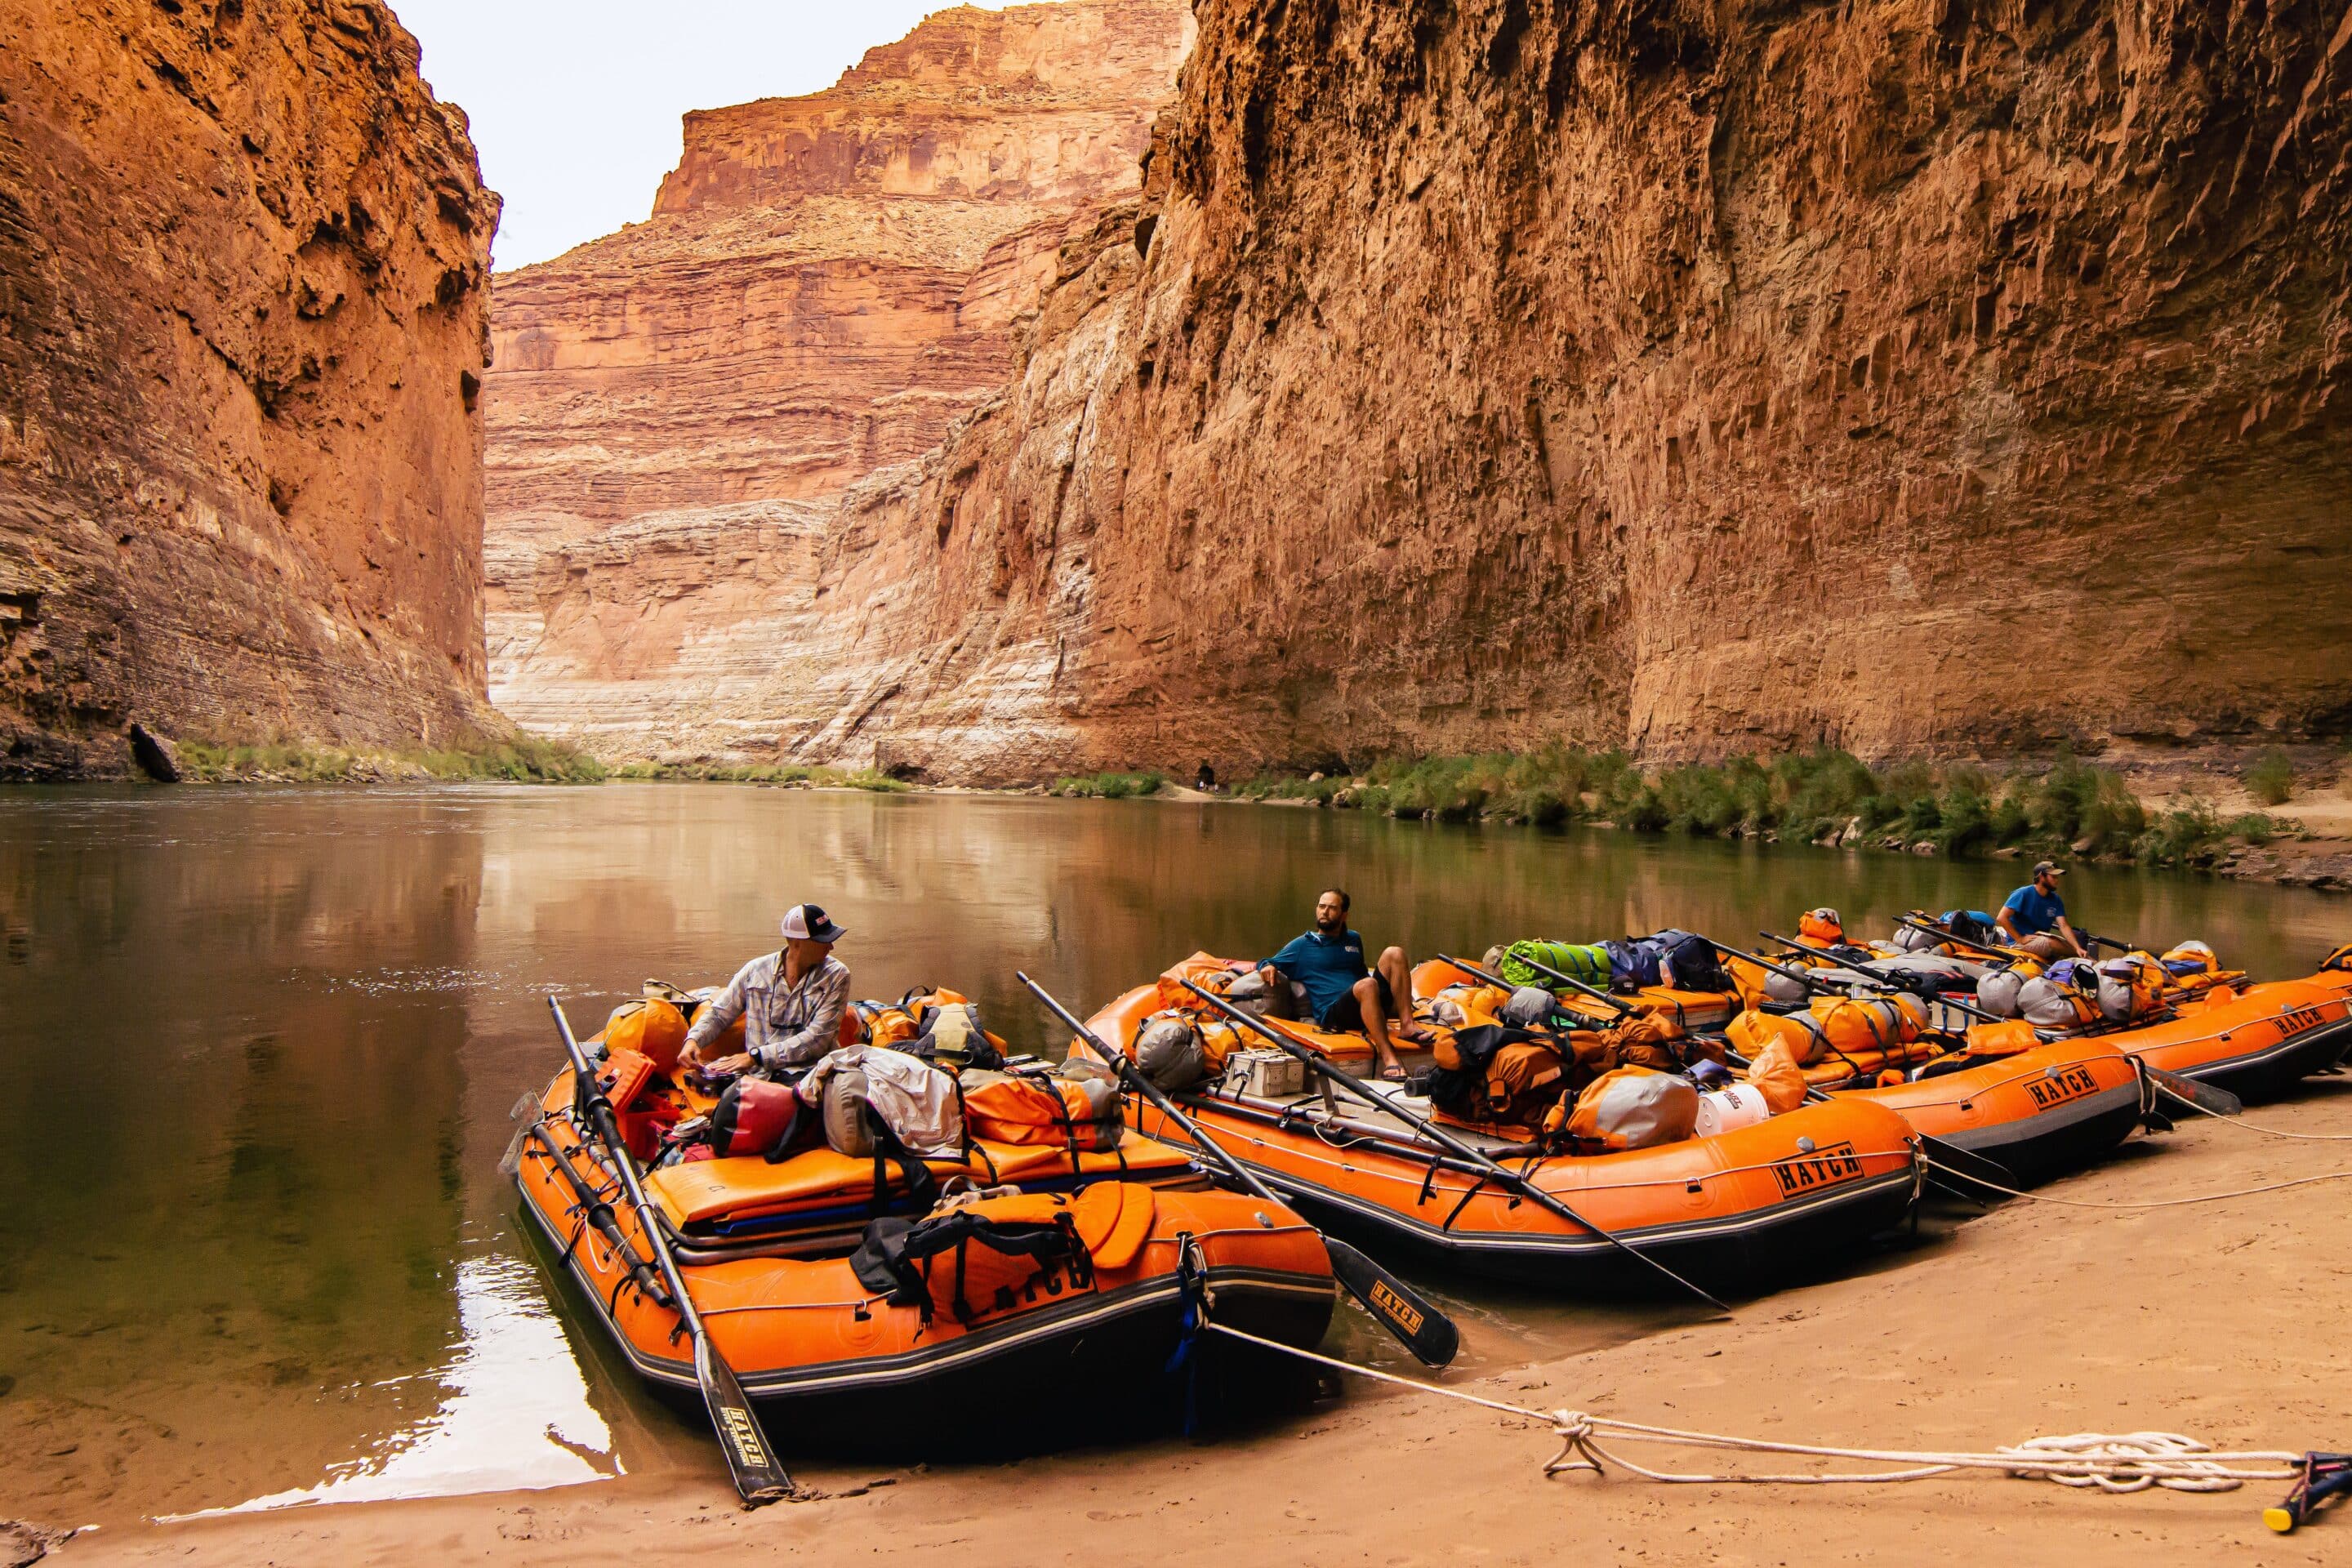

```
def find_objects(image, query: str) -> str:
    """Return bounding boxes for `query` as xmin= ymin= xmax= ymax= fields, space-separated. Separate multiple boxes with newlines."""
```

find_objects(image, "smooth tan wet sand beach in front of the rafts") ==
xmin=47 ymin=1079 xmax=2352 ymax=1568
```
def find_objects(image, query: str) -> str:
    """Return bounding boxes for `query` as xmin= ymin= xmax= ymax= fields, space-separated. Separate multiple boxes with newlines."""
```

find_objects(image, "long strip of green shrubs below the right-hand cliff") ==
xmin=1235 ymin=746 xmax=2283 ymax=865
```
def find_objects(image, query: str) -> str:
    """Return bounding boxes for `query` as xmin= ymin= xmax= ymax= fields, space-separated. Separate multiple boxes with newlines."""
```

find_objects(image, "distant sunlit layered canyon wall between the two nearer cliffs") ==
xmin=487 ymin=0 xmax=1192 ymax=757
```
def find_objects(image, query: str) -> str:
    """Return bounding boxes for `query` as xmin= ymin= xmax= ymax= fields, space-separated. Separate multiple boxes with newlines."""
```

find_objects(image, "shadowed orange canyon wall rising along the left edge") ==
xmin=0 ymin=0 xmax=503 ymax=778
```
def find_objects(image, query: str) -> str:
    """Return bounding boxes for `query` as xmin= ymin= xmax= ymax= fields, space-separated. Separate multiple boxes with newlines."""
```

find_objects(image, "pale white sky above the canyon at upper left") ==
xmin=390 ymin=0 xmax=1009 ymax=268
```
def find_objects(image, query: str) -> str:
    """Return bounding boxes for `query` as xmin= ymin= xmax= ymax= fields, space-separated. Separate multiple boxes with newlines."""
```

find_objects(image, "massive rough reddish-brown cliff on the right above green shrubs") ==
xmin=491 ymin=0 xmax=2352 ymax=781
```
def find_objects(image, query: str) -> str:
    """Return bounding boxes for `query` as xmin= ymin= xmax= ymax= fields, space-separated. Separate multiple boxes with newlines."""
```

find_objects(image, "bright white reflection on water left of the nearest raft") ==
xmin=181 ymin=1260 xmax=621 ymax=1519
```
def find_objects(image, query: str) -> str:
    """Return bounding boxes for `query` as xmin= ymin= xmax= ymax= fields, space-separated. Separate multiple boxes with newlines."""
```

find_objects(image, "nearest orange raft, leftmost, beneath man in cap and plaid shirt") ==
xmin=510 ymin=1034 xmax=1334 ymax=1453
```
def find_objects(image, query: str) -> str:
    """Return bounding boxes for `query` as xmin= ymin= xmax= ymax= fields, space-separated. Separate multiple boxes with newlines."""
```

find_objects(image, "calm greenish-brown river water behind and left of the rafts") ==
xmin=0 ymin=785 xmax=2352 ymax=1523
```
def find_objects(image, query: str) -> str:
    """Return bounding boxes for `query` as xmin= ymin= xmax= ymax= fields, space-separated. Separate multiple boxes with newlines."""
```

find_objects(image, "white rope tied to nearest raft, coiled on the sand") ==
xmin=1202 ymin=1316 xmax=2303 ymax=1493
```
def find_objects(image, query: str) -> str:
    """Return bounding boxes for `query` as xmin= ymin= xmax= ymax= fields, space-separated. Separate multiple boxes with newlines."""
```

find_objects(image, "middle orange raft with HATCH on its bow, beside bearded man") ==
xmin=1072 ymin=955 xmax=1924 ymax=1293
